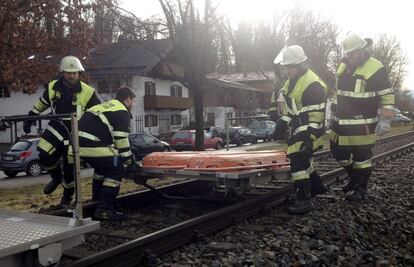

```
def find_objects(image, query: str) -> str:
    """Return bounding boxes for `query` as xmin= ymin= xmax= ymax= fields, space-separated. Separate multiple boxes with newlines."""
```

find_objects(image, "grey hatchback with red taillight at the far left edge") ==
xmin=0 ymin=138 xmax=43 ymax=177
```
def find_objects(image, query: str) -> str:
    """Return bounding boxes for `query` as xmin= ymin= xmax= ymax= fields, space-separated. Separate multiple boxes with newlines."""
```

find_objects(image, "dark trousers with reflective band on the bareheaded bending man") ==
xmin=82 ymin=156 xmax=125 ymax=209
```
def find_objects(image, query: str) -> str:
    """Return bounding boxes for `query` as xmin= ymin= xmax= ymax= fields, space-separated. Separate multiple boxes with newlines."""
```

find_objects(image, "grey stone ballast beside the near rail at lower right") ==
xmin=157 ymin=148 xmax=414 ymax=267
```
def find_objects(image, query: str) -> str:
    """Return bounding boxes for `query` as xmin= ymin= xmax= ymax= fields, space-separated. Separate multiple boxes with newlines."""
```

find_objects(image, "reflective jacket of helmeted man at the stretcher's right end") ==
xmin=276 ymin=70 xmax=327 ymax=154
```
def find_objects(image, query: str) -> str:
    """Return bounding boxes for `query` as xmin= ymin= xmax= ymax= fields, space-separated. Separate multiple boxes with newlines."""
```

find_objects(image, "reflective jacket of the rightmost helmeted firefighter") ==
xmin=330 ymin=57 xmax=395 ymax=146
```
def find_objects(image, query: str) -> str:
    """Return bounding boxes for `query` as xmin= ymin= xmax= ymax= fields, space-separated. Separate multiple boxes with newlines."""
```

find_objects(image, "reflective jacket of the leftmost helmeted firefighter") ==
xmin=31 ymin=78 xmax=101 ymax=126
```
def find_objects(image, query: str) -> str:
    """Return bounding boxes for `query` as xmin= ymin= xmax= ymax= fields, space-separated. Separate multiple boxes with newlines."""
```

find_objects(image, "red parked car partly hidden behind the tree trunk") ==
xmin=170 ymin=130 xmax=223 ymax=151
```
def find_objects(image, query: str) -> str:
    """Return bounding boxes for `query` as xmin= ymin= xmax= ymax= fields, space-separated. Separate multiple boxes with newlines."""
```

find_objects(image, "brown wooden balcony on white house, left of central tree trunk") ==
xmin=144 ymin=95 xmax=193 ymax=109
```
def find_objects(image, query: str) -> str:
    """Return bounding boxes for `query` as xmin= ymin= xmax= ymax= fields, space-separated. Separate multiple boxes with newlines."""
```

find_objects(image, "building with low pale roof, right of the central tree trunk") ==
xmin=204 ymin=72 xmax=276 ymax=127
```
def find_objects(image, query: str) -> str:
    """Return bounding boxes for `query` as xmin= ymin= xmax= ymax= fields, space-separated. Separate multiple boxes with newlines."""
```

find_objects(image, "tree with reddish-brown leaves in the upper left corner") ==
xmin=0 ymin=0 xmax=119 ymax=93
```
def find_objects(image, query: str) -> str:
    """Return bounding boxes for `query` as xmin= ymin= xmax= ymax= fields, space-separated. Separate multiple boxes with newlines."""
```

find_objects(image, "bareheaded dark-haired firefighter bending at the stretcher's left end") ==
xmin=76 ymin=87 xmax=141 ymax=221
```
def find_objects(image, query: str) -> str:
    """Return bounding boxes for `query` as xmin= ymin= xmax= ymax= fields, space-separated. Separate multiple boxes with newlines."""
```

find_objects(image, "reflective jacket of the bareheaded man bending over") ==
xmin=79 ymin=99 xmax=133 ymax=165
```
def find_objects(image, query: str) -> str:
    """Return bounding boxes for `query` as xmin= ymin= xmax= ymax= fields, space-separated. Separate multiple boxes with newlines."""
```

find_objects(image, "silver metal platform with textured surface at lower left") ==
xmin=0 ymin=209 xmax=99 ymax=266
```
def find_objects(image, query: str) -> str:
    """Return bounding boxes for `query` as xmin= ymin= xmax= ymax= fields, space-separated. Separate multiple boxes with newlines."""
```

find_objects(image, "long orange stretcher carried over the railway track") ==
xmin=142 ymin=151 xmax=289 ymax=172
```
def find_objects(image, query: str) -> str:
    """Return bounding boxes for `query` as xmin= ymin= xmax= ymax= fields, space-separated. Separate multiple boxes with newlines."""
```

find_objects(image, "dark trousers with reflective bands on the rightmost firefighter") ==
xmin=331 ymin=141 xmax=374 ymax=179
